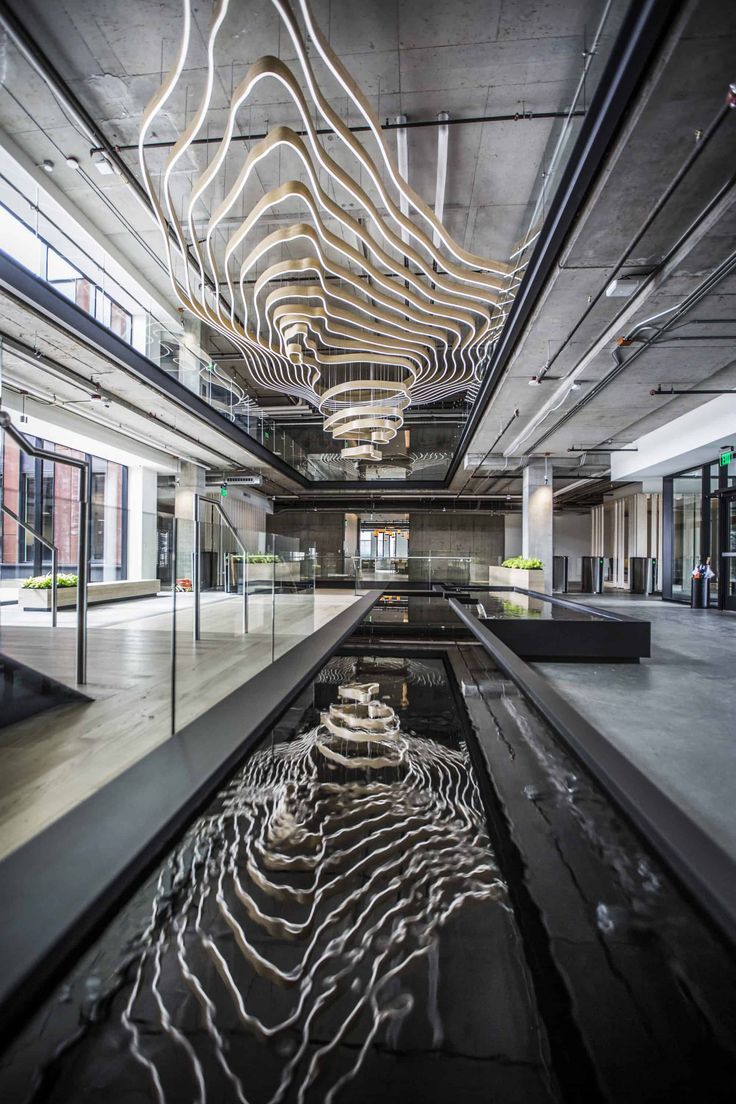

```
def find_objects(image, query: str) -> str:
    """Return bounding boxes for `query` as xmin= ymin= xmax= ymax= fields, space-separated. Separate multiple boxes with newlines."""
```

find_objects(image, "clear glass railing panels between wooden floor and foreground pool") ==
xmin=0 ymin=472 xmax=317 ymax=737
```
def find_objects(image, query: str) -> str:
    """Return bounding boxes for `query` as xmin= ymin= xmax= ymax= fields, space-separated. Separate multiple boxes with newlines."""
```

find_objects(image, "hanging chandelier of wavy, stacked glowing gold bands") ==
xmin=139 ymin=0 xmax=518 ymax=460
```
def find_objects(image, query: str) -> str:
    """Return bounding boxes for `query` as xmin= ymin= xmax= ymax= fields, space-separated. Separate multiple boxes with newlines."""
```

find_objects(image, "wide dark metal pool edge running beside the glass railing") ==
xmin=0 ymin=591 xmax=381 ymax=1043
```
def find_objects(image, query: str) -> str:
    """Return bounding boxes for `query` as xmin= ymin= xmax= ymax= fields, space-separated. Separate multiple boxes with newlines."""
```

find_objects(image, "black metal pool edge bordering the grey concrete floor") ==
xmin=450 ymin=598 xmax=736 ymax=942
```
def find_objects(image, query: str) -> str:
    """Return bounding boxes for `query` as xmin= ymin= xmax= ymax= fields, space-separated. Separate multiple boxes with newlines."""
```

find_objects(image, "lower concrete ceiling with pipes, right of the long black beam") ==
xmin=456 ymin=0 xmax=736 ymax=501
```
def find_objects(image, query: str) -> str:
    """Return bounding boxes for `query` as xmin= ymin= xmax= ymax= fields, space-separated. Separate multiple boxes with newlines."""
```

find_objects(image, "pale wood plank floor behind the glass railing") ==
xmin=0 ymin=591 xmax=358 ymax=857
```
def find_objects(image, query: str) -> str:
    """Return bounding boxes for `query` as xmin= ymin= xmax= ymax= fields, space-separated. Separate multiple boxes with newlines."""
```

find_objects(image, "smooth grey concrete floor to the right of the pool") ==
xmin=532 ymin=596 xmax=736 ymax=854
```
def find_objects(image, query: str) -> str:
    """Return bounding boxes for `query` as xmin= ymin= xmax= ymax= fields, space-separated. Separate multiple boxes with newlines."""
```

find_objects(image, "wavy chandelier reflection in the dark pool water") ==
xmin=115 ymin=670 xmax=504 ymax=1104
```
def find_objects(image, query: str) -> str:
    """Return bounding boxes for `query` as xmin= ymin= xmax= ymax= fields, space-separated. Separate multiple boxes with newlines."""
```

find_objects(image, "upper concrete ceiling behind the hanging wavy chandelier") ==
xmin=0 ymin=0 xmax=627 ymax=439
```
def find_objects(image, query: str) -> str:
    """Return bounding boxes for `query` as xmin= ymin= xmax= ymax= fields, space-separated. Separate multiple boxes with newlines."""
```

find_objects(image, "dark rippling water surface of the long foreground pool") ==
xmin=0 ymin=646 xmax=736 ymax=1104
